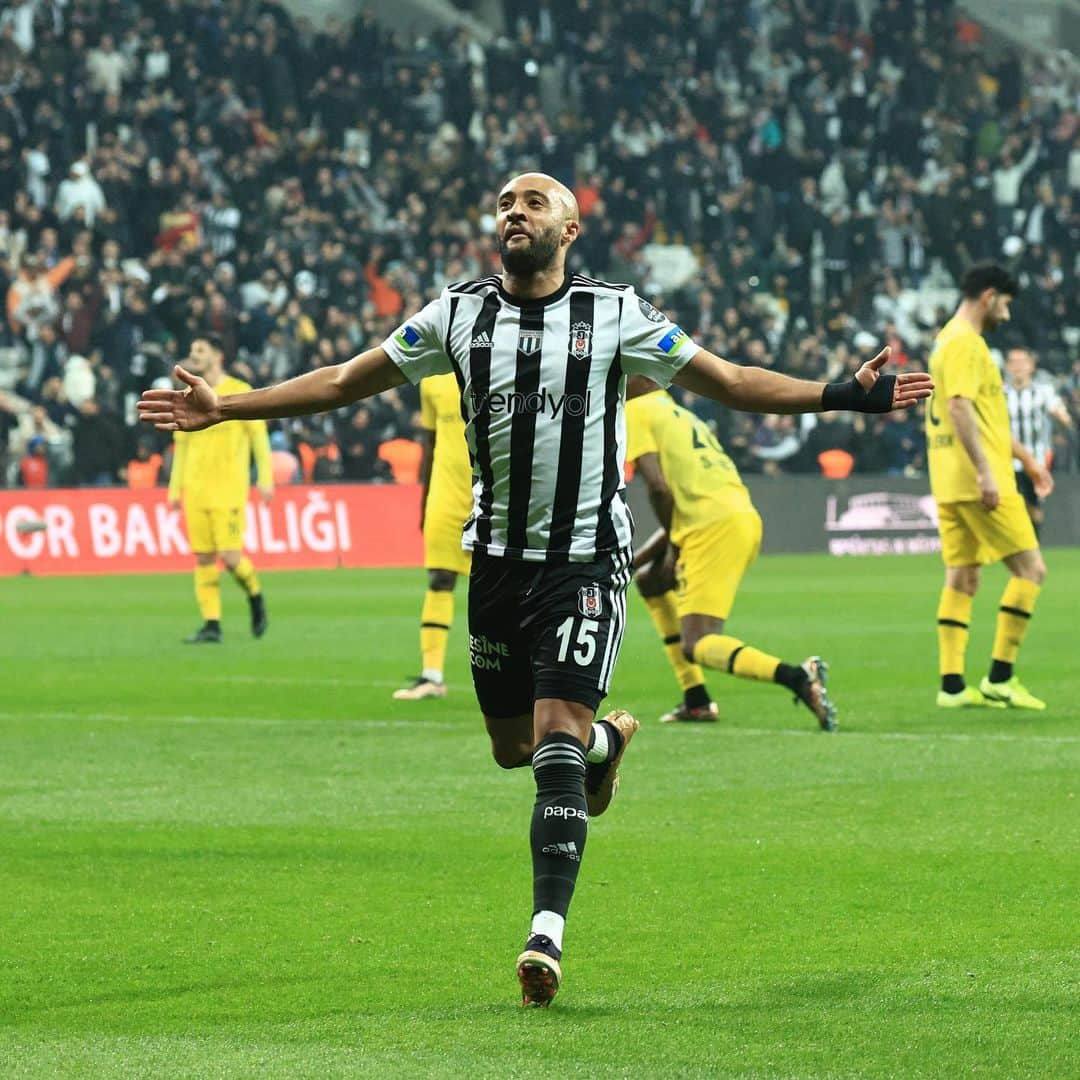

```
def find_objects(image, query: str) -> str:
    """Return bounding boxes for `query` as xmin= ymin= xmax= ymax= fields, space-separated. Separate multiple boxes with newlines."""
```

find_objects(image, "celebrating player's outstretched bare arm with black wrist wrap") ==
xmin=675 ymin=348 xmax=933 ymax=413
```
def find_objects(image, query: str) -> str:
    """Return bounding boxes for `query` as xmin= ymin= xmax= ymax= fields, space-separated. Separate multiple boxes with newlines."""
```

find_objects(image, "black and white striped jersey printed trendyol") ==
xmin=382 ymin=274 xmax=698 ymax=562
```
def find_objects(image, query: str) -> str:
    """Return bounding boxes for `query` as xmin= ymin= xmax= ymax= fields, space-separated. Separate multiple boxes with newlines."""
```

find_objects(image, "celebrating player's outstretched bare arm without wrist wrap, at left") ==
xmin=138 ymin=347 xmax=405 ymax=431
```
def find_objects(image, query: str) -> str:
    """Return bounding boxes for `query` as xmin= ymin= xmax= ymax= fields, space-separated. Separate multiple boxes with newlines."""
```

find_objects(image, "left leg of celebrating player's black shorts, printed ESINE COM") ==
xmin=469 ymin=555 xmax=532 ymax=731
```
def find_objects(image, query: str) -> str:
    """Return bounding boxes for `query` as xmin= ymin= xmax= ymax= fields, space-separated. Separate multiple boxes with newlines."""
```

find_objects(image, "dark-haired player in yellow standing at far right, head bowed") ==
xmin=927 ymin=264 xmax=1053 ymax=708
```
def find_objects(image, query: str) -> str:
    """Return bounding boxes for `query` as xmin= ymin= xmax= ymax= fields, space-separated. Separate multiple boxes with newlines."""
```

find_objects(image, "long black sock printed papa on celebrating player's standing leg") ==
xmin=529 ymin=732 xmax=589 ymax=917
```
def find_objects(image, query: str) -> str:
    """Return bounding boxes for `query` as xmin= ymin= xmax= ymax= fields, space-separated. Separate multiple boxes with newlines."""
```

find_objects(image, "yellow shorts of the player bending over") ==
xmin=675 ymin=510 xmax=761 ymax=619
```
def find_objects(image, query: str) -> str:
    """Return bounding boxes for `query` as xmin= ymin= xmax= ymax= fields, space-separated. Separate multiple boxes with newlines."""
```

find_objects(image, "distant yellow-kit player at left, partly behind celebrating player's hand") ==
xmin=168 ymin=334 xmax=273 ymax=645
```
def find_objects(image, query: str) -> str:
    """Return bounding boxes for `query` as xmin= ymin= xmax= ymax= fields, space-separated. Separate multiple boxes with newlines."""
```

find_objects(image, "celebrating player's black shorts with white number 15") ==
xmin=469 ymin=551 xmax=631 ymax=717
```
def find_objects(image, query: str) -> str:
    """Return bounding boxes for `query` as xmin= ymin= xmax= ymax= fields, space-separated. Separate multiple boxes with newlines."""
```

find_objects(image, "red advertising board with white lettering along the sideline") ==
xmin=0 ymin=484 xmax=423 ymax=575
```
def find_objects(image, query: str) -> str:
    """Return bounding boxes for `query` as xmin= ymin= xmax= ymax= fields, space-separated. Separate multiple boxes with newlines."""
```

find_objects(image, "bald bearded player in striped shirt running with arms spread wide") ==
xmin=139 ymin=173 xmax=931 ymax=1005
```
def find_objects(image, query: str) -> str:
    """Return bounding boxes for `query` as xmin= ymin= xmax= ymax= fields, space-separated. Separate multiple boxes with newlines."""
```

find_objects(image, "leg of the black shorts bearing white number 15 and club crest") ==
xmin=524 ymin=552 xmax=632 ymax=712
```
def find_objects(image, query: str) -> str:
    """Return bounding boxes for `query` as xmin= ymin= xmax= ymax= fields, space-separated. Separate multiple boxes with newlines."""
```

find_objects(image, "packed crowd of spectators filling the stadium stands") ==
xmin=0 ymin=0 xmax=1080 ymax=486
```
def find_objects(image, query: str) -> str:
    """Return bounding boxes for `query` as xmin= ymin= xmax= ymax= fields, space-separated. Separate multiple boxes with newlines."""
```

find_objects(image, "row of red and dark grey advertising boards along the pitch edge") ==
xmin=0 ymin=476 xmax=1080 ymax=575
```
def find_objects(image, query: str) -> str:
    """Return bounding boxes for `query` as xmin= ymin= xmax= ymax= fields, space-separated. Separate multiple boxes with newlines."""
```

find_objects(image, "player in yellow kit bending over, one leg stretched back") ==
xmin=626 ymin=375 xmax=836 ymax=731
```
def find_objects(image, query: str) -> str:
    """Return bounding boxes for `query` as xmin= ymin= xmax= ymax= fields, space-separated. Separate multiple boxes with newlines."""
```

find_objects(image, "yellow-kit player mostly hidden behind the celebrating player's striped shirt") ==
xmin=394 ymin=375 xmax=472 ymax=701
